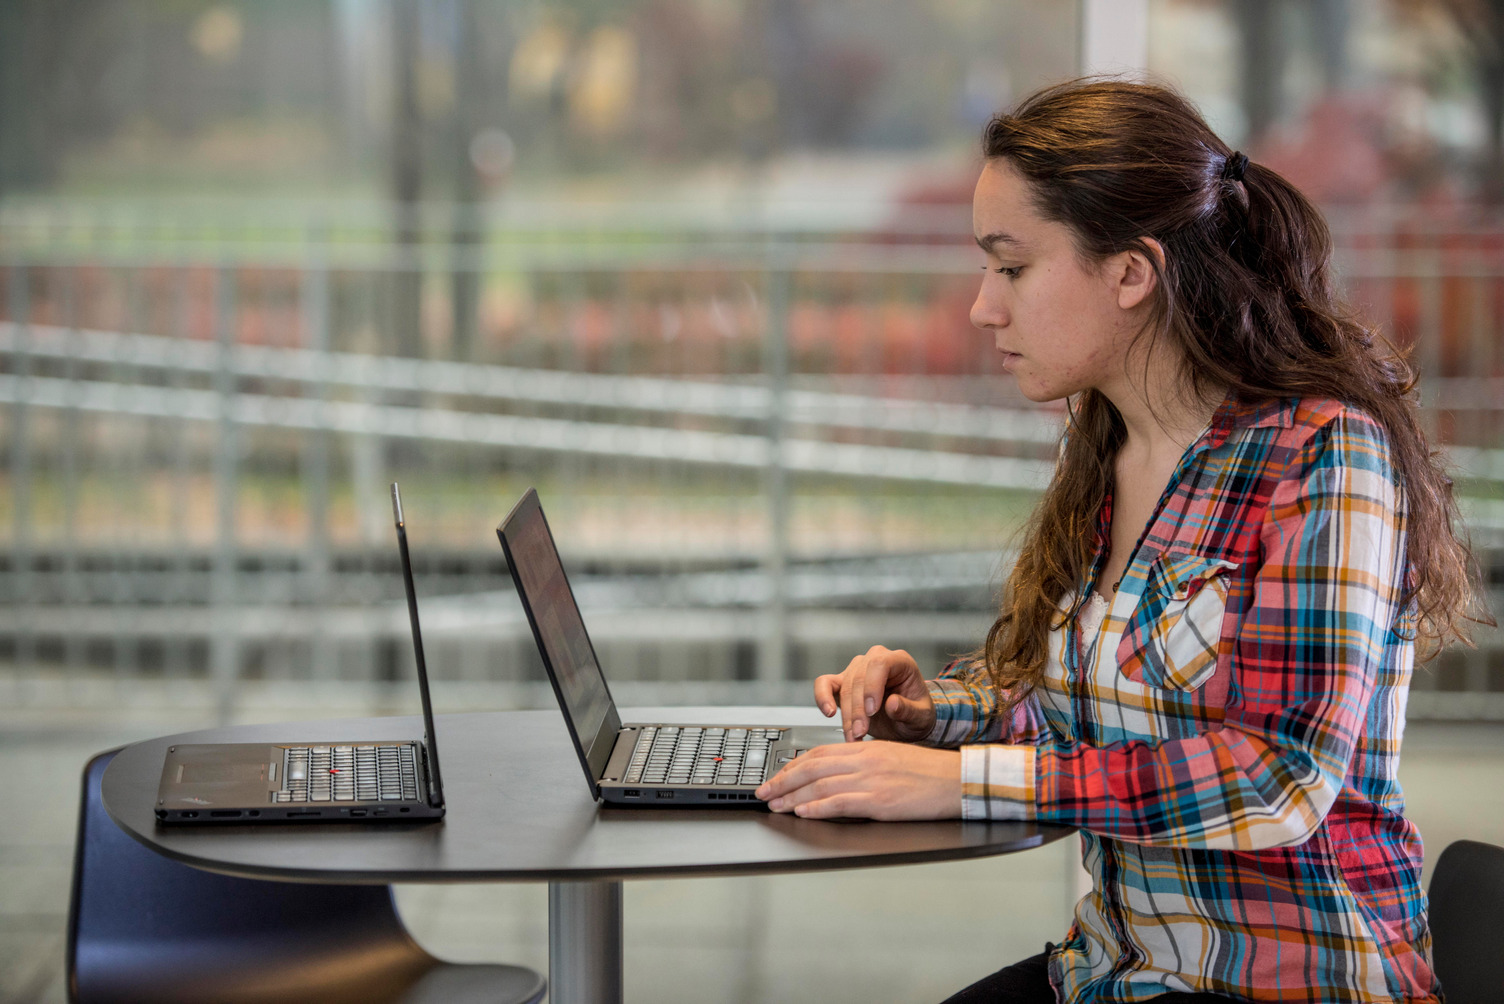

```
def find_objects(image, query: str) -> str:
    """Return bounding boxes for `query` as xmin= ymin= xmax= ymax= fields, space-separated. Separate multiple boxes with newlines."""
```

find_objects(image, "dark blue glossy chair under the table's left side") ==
xmin=68 ymin=750 xmax=544 ymax=1004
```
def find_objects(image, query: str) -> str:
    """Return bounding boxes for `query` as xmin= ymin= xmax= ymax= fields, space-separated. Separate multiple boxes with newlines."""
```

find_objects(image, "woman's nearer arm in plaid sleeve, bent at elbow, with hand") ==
xmin=760 ymin=413 xmax=1405 ymax=851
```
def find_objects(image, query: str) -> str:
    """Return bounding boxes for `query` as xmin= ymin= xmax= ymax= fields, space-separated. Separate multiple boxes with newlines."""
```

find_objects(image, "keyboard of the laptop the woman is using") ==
xmin=624 ymin=726 xmax=784 ymax=785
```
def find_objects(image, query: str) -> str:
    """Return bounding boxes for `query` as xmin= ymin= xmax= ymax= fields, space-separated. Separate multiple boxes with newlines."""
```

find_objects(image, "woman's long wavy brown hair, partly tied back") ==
xmin=973 ymin=80 xmax=1492 ymax=706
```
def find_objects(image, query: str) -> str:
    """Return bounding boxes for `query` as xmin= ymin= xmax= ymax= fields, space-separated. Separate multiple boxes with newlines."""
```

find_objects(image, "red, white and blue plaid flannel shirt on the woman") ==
xmin=928 ymin=400 xmax=1439 ymax=1004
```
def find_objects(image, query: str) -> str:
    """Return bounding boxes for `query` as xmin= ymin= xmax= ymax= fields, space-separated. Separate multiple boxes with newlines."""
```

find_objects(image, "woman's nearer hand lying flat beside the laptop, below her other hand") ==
xmin=757 ymin=739 xmax=961 ymax=819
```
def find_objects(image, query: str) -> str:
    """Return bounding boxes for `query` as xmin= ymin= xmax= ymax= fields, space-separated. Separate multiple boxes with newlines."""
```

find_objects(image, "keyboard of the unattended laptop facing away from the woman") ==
xmin=272 ymin=742 xmax=418 ymax=801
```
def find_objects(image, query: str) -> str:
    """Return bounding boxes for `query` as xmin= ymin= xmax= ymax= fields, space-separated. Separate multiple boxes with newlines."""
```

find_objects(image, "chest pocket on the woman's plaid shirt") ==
xmin=1117 ymin=555 xmax=1238 ymax=690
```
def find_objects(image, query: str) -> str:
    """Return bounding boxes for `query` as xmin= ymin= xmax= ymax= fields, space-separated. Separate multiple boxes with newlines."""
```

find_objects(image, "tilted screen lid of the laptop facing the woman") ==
xmin=496 ymin=488 xmax=621 ymax=798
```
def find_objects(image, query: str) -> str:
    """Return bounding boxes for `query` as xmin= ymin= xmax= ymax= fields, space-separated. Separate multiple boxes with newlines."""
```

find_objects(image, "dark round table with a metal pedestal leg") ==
xmin=102 ymin=708 xmax=1071 ymax=1001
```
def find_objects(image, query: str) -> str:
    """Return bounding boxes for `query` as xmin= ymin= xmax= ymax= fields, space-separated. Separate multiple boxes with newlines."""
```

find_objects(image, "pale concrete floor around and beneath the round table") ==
xmin=0 ymin=684 xmax=1504 ymax=1004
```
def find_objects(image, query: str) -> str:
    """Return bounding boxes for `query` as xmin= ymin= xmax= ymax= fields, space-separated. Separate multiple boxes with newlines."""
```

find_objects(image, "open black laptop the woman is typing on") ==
xmin=496 ymin=488 xmax=842 ymax=807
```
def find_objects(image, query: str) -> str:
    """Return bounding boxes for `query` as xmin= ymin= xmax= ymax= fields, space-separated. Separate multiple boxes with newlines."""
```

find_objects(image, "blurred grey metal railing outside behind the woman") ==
xmin=0 ymin=204 xmax=1504 ymax=717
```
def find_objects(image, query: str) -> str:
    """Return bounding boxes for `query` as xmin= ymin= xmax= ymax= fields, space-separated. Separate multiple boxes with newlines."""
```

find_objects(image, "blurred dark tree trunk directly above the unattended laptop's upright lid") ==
xmin=391 ymin=0 xmax=423 ymax=358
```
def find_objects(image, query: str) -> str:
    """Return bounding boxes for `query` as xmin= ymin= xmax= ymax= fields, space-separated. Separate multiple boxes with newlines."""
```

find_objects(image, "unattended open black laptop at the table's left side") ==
xmin=156 ymin=482 xmax=444 ymax=825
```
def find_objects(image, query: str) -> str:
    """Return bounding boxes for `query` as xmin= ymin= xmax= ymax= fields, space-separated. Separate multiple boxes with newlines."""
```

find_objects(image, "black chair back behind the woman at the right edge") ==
xmin=1429 ymin=840 xmax=1504 ymax=1004
